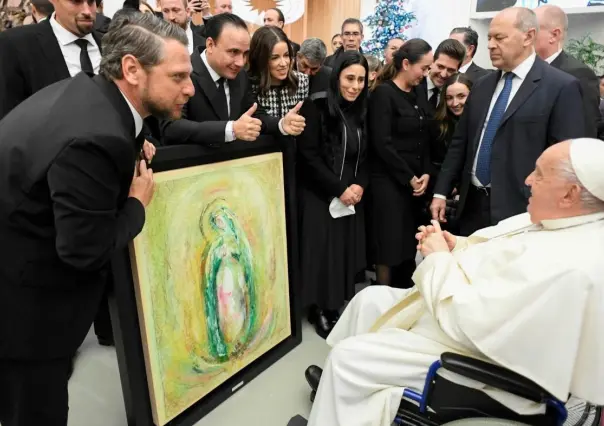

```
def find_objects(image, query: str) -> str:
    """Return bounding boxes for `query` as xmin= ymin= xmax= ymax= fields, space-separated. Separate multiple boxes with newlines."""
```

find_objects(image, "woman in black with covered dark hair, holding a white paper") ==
xmin=298 ymin=52 xmax=368 ymax=337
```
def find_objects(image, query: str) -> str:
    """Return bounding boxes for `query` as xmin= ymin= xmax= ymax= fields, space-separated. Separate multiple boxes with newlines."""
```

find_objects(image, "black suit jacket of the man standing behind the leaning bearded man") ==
xmin=0 ymin=18 xmax=102 ymax=119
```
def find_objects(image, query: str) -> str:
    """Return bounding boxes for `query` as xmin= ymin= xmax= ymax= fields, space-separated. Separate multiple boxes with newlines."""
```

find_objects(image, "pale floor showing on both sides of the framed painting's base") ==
xmin=69 ymin=322 xmax=329 ymax=426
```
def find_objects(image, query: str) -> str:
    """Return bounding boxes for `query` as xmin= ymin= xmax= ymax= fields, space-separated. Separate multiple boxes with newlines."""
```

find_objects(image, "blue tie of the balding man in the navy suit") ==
xmin=476 ymin=72 xmax=514 ymax=186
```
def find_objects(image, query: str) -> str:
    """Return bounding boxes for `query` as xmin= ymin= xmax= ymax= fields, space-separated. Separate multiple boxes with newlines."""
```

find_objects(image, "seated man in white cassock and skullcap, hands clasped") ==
xmin=308 ymin=139 xmax=604 ymax=426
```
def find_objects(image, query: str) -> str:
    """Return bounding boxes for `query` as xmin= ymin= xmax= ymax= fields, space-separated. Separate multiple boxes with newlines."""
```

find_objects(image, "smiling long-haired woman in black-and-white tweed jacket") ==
xmin=248 ymin=27 xmax=309 ymax=118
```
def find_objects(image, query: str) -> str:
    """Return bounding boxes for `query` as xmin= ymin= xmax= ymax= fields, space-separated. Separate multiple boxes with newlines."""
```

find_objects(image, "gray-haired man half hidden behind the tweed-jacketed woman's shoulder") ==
xmin=296 ymin=38 xmax=331 ymax=94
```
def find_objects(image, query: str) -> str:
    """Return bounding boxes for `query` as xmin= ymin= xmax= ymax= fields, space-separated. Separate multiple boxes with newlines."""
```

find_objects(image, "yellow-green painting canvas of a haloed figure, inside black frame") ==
xmin=130 ymin=153 xmax=291 ymax=426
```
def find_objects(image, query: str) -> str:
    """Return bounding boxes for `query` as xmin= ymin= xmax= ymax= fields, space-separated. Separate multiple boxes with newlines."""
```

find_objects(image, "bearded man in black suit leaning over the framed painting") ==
xmin=0 ymin=12 xmax=194 ymax=426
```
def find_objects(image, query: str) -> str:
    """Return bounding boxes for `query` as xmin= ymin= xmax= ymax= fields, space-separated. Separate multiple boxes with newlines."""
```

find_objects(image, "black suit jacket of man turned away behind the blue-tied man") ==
xmin=551 ymin=51 xmax=602 ymax=138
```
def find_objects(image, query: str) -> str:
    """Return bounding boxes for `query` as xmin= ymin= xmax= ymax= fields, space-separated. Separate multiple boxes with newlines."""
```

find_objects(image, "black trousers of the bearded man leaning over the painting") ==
xmin=0 ymin=358 xmax=71 ymax=426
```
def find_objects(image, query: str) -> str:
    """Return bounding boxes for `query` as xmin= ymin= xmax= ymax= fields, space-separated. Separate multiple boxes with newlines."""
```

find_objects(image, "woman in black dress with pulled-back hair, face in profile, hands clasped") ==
xmin=367 ymin=39 xmax=437 ymax=288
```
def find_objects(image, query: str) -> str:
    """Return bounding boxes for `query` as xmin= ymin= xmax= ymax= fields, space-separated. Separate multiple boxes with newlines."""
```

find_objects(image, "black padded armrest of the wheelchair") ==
xmin=440 ymin=352 xmax=556 ymax=402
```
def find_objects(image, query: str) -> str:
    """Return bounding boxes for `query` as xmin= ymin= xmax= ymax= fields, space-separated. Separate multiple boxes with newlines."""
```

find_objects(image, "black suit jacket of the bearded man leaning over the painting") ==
xmin=0 ymin=74 xmax=145 ymax=359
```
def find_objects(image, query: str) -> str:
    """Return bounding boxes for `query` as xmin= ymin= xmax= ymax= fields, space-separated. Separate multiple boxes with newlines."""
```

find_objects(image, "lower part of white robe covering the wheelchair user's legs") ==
xmin=308 ymin=286 xmax=458 ymax=426
